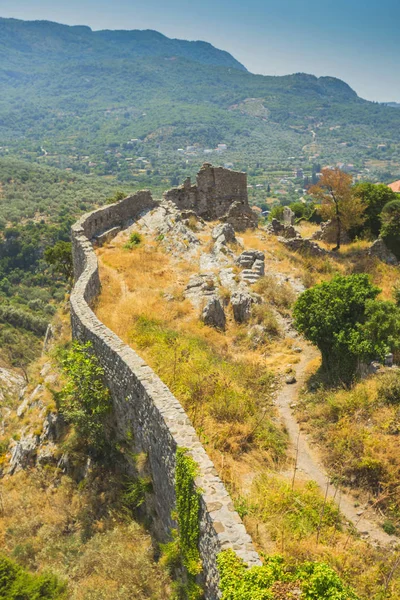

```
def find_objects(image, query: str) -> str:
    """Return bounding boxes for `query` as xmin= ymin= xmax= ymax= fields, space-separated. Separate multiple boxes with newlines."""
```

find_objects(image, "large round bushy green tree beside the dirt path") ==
xmin=293 ymin=274 xmax=400 ymax=383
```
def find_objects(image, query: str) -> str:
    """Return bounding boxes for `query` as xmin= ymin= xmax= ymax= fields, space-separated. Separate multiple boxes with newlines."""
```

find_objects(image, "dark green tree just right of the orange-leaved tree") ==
xmin=353 ymin=183 xmax=396 ymax=237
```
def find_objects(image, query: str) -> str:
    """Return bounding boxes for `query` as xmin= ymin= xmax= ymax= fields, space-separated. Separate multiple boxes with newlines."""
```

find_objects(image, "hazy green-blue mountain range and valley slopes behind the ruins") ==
xmin=0 ymin=14 xmax=400 ymax=179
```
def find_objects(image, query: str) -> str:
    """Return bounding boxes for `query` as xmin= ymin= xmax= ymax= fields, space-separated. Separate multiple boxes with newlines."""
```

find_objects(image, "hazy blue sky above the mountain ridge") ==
xmin=0 ymin=0 xmax=400 ymax=102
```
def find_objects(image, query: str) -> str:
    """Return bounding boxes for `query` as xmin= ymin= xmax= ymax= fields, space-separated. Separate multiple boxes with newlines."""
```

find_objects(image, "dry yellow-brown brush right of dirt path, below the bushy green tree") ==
xmin=299 ymin=371 xmax=400 ymax=531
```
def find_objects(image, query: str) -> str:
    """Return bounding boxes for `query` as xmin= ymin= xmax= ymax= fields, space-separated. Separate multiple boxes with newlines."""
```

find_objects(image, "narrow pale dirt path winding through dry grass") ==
xmin=275 ymin=345 xmax=397 ymax=545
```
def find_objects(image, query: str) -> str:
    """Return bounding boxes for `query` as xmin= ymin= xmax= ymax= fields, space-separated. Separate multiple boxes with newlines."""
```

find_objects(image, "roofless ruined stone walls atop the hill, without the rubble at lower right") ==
xmin=164 ymin=163 xmax=249 ymax=220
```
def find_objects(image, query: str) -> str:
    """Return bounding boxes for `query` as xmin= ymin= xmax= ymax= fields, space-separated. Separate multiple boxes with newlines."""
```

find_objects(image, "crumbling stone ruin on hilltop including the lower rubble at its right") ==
xmin=164 ymin=163 xmax=258 ymax=231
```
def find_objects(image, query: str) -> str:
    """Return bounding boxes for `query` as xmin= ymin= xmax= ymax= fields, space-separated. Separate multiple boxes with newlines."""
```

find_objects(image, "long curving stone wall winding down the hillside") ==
xmin=70 ymin=192 xmax=260 ymax=600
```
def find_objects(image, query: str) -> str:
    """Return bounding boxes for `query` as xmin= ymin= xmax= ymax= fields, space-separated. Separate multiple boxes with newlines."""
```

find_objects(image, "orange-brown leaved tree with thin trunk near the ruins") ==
xmin=309 ymin=169 xmax=365 ymax=250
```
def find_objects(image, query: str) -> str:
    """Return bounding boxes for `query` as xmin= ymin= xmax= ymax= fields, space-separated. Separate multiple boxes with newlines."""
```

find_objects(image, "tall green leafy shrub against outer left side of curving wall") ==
xmin=57 ymin=342 xmax=111 ymax=450
